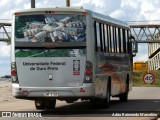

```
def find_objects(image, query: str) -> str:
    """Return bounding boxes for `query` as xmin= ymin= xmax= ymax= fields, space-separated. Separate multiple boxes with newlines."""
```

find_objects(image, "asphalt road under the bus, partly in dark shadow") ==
xmin=0 ymin=81 xmax=160 ymax=120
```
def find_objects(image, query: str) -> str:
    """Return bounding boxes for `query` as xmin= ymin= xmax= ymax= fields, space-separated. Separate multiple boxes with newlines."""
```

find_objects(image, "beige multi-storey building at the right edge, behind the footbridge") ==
xmin=148 ymin=34 xmax=160 ymax=70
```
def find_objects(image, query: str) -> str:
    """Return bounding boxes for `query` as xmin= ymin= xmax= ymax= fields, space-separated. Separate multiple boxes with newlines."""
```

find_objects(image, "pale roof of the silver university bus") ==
xmin=15 ymin=7 xmax=129 ymax=28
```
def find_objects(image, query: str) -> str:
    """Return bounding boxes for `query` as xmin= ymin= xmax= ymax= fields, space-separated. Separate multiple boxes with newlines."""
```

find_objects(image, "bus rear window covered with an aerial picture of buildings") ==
xmin=15 ymin=14 xmax=86 ymax=42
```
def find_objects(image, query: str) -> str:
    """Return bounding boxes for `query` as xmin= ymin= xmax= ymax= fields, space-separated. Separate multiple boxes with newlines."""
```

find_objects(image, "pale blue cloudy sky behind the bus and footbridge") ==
xmin=0 ymin=0 xmax=160 ymax=76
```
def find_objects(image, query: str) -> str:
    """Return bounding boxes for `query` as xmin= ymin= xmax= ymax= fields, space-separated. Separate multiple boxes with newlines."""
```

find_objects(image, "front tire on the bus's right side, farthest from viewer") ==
xmin=119 ymin=81 xmax=129 ymax=102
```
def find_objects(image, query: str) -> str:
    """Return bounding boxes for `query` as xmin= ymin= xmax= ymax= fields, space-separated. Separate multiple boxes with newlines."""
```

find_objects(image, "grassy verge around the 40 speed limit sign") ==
xmin=133 ymin=70 xmax=160 ymax=87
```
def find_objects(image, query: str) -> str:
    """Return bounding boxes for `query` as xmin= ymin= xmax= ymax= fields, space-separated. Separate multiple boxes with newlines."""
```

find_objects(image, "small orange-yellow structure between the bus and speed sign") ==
xmin=133 ymin=61 xmax=148 ymax=70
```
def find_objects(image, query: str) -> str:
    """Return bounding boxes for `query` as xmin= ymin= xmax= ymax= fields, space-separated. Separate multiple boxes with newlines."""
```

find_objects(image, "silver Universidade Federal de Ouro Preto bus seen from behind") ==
xmin=11 ymin=7 xmax=132 ymax=110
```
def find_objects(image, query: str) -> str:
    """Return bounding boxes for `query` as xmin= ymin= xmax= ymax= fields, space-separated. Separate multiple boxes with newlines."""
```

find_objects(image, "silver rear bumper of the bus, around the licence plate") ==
xmin=12 ymin=83 xmax=94 ymax=99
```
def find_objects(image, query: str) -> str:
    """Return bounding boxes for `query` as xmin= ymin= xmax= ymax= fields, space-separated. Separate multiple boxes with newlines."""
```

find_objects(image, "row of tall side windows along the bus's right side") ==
xmin=94 ymin=21 xmax=129 ymax=53
